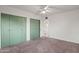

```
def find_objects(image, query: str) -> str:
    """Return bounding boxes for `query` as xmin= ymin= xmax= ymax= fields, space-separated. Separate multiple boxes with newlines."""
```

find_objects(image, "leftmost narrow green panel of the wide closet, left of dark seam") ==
xmin=1 ymin=14 xmax=10 ymax=47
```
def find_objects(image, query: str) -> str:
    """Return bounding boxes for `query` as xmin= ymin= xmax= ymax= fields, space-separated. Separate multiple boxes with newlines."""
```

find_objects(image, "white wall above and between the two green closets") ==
xmin=0 ymin=5 xmax=41 ymax=45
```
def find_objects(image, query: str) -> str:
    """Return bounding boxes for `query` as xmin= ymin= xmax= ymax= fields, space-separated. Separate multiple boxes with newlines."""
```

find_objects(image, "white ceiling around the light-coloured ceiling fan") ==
xmin=9 ymin=5 xmax=79 ymax=14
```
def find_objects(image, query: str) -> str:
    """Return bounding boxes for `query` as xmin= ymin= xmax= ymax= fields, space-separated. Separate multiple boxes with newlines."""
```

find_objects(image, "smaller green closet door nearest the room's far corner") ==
xmin=30 ymin=19 xmax=40 ymax=40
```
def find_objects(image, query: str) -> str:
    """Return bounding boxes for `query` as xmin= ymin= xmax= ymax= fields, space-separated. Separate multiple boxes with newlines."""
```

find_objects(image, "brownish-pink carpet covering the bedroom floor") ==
xmin=0 ymin=38 xmax=79 ymax=53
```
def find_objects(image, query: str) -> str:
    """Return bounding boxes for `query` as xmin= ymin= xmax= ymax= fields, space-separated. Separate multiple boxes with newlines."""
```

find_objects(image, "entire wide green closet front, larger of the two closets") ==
xmin=1 ymin=14 xmax=26 ymax=47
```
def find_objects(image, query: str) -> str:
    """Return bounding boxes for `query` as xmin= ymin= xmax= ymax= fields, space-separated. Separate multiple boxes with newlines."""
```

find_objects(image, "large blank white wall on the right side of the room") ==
xmin=48 ymin=10 xmax=79 ymax=43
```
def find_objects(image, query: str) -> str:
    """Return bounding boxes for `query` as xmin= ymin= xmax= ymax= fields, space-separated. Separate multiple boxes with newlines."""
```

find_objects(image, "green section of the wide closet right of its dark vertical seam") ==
xmin=10 ymin=16 xmax=26 ymax=45
